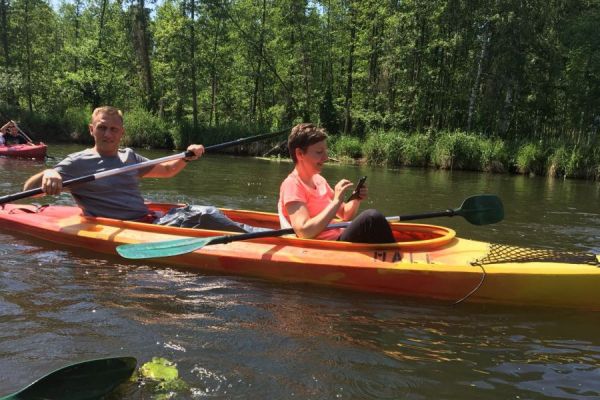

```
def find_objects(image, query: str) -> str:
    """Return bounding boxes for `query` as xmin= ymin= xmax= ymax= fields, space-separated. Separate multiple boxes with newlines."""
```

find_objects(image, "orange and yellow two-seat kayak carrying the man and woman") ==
xmin=0 ymin=204 xmax=600 ymax=310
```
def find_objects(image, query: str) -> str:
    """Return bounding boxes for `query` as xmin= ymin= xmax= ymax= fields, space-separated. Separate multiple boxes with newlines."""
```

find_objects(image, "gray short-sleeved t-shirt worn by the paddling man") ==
xmin=54 ymin=148 xmax=148 ymax=220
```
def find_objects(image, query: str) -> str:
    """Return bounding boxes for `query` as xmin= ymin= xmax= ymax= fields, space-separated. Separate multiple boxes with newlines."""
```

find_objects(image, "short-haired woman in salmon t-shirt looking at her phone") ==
xmin=277 ymin=123 xmax=395 ymax=243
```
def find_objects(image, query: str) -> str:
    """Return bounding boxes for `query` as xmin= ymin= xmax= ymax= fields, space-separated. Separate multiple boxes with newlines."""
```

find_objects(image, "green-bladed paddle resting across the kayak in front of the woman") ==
xmin=117 ymin=194 xmax=504 ymax=259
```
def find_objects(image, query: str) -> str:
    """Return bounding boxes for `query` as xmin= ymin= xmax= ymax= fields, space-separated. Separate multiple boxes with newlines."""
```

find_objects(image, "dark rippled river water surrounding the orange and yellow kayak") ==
xmin=0 ymin=145 xmax=600 ymax=399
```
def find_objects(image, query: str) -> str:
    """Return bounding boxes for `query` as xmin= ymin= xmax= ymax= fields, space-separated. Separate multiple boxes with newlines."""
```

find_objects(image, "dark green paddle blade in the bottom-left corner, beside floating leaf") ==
xmin=0 ymin=357 xmax=137 ymax=400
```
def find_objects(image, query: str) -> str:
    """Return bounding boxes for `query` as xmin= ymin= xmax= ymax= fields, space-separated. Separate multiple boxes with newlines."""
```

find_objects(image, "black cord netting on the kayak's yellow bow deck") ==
xmin=471 ymin=244 xmax=600 ymax=267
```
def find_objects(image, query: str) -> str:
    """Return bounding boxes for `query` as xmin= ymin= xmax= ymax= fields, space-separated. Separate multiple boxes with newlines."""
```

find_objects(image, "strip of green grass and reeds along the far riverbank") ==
xmin=5 ymin=106 xmax=600 ymax=181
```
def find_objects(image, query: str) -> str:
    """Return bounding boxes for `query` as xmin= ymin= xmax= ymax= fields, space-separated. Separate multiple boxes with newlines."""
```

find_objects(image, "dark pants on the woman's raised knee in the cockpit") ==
xmin=338 ymin=209 xmax=396 ymax=243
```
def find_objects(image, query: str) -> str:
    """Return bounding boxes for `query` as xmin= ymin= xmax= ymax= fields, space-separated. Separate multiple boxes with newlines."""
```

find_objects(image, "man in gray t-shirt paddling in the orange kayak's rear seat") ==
xmin=24 ymin=106 xmax=266 ymax=232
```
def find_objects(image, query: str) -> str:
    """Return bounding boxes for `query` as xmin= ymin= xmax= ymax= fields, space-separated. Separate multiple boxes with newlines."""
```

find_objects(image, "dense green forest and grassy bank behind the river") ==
xmin=0 ymin=0 xmax=600 ymax=180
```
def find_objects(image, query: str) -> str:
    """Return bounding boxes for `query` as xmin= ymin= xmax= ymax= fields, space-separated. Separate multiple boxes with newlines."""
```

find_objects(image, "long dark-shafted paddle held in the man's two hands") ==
xmin=0 ymin=131 xmax=285 ymax=204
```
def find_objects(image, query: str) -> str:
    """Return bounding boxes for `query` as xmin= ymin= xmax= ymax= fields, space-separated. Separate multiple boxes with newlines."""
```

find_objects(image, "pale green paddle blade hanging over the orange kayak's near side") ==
xmin=117 ymin=237 xmax=215 ymax=259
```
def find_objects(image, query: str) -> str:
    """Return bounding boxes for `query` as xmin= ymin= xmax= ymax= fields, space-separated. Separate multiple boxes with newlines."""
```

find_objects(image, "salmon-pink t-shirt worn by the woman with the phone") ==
xmin=278 ymin=171 xmax=342 ymax=240
